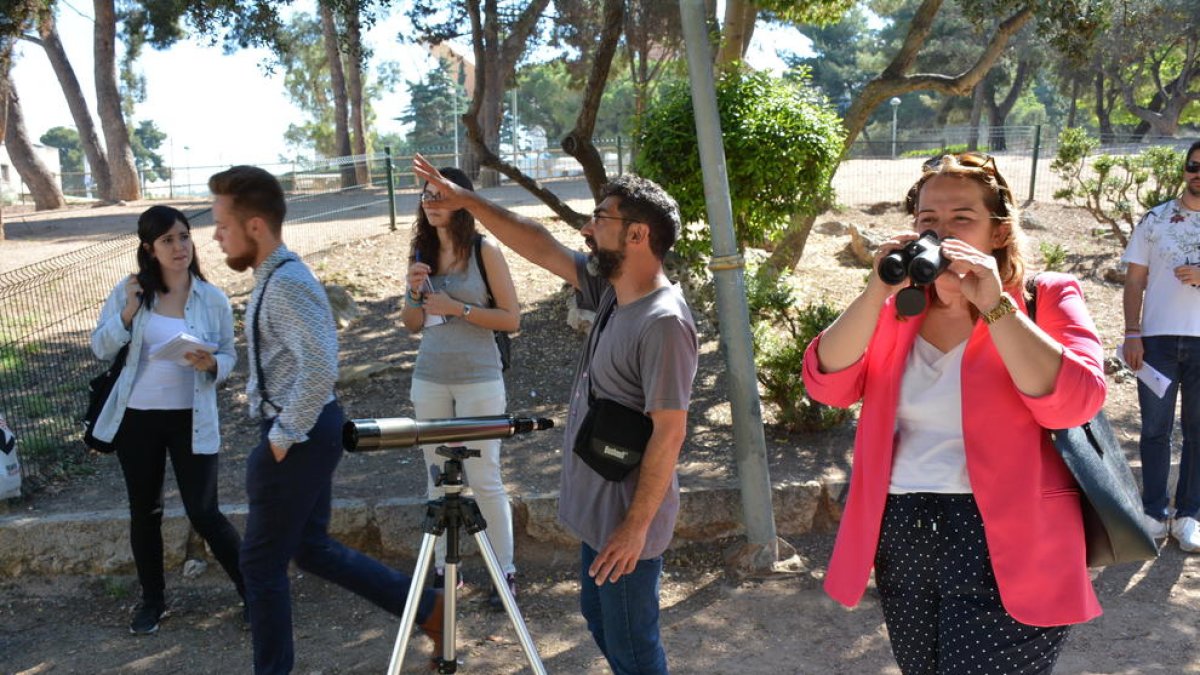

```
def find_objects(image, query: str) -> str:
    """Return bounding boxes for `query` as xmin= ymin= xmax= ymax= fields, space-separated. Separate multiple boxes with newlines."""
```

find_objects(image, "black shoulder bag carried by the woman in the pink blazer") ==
xmin=1026 ymin=277 xmax=1158 ymax=567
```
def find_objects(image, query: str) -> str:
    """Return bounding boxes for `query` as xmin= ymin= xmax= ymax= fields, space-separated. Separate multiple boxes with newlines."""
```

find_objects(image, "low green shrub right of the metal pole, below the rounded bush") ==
xmin=746 ymin=267 xmax=851 ymax=431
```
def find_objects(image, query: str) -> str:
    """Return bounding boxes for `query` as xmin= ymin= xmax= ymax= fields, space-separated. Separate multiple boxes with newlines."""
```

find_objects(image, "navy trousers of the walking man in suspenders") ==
xmin=241 ymin=402 xmax=434 ymax=674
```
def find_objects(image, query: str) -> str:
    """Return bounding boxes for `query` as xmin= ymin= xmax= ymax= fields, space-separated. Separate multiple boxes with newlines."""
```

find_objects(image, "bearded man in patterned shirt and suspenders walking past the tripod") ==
xmin=209 ymin=166 xmax=443 ymax=674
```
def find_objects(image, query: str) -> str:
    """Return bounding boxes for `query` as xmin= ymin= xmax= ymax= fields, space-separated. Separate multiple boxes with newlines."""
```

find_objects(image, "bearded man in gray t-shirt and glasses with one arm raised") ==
xmin=413 ymin=155 xmax=698 ymax=675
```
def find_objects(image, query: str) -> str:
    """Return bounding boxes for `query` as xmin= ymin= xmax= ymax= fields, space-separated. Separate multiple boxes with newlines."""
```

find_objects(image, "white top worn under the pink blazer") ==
xmin=888 ymin=335 xmax=971 ymax=495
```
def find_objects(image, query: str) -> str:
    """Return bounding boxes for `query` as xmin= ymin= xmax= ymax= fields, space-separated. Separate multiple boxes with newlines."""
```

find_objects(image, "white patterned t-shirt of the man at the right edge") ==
xmin=1121 ymin=199 xmax=1200 ymax=336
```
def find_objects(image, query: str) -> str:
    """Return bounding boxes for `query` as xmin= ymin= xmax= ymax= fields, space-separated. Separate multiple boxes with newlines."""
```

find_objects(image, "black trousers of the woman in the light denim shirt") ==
xmin=114 ymin=410 xmax=245 ymax=605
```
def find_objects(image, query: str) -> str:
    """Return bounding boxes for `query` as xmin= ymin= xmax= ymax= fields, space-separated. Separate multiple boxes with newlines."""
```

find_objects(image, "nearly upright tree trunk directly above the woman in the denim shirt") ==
xmin=92 ymin=0 xmax=142 ymax=201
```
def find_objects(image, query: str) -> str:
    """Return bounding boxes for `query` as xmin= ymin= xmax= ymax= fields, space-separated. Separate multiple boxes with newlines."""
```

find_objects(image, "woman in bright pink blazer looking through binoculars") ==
xmin=804 ymin=153 xmax=1106 ymax=675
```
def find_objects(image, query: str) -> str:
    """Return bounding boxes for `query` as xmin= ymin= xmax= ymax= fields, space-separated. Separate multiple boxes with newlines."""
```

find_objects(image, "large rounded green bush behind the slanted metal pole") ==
xmin=636 ymin=68 xmax=844 ymax=261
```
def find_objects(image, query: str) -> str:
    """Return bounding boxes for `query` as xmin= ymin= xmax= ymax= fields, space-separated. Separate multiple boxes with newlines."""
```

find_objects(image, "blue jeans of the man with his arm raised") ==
xmin=580 ymin=544 xmax=667 ymax=675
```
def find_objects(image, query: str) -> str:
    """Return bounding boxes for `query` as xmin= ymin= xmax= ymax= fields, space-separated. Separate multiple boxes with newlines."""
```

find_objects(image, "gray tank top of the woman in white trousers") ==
xmin=413 ymin=242 xmax=504 ymax=384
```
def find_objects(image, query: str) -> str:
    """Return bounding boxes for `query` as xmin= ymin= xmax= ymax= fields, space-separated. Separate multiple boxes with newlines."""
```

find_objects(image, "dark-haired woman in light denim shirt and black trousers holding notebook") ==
xmin=91 ymin=205 xmax=244 ymax=634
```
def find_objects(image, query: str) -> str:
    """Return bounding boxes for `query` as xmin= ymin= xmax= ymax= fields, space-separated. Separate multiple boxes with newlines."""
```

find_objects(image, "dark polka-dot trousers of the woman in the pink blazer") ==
xmin=875 ymin=494 xmax=1067 ymax=675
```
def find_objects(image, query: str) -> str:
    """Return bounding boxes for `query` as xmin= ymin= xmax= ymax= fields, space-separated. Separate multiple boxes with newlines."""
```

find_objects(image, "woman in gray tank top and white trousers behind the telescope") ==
xmin=402 ymin=167 xmax=521 ymax=609
